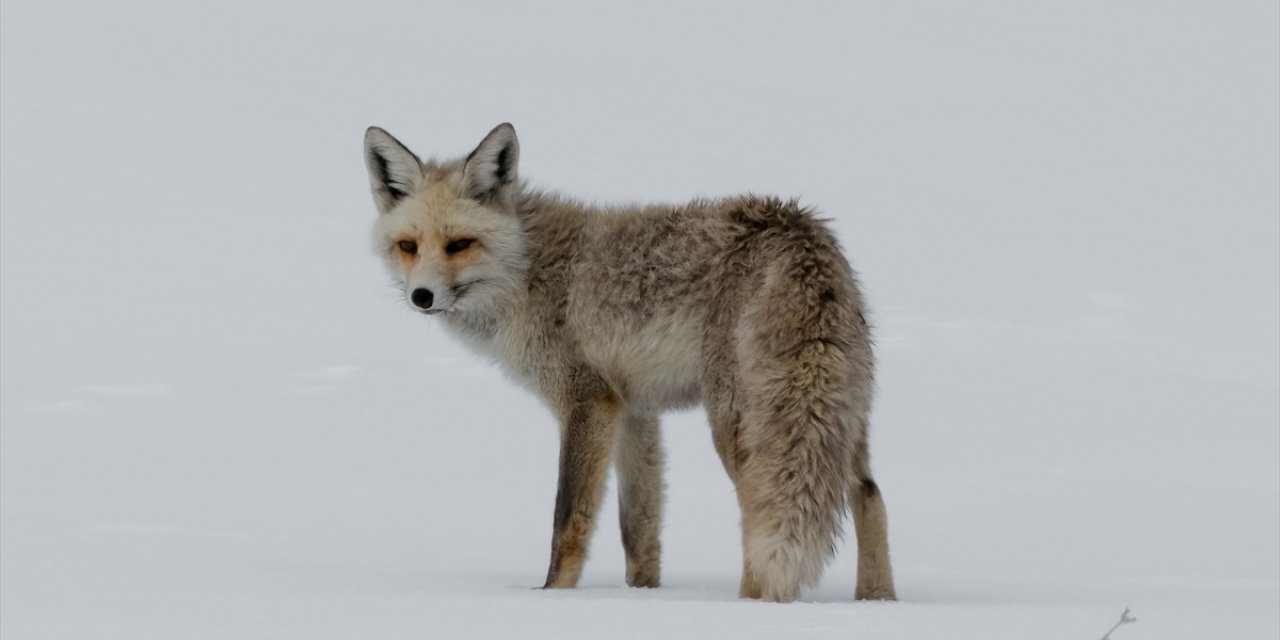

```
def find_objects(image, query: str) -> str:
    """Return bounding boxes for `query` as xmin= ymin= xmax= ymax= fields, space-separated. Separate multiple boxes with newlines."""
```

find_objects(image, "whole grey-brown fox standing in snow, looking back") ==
xmin=365 ymin=123 xmax=896 ymax=603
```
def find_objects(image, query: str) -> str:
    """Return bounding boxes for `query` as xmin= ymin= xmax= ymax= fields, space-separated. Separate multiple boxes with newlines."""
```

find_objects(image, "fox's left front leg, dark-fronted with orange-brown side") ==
xmin=545 ymin=390 xmax=622 ymax=589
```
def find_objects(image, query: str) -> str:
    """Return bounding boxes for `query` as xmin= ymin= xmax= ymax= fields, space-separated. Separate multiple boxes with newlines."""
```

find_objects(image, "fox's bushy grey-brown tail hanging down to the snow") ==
xmin=737 ymin=216 xmax=872 ymax=602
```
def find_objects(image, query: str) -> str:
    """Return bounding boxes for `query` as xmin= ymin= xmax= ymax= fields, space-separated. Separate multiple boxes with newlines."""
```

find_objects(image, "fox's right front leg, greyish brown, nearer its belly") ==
xmin=616 ymin=415 xmax=664 ymax=588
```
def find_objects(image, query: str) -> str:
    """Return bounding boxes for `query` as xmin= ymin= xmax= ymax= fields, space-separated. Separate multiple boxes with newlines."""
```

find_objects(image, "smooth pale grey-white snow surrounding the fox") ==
xmin=0 ymin=0 xmax=1280 ymax=640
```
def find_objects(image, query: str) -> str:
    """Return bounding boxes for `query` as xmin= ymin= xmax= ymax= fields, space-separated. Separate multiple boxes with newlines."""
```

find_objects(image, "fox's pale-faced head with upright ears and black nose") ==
xmin=365 ymin=123 xmax=525 ymax=314
